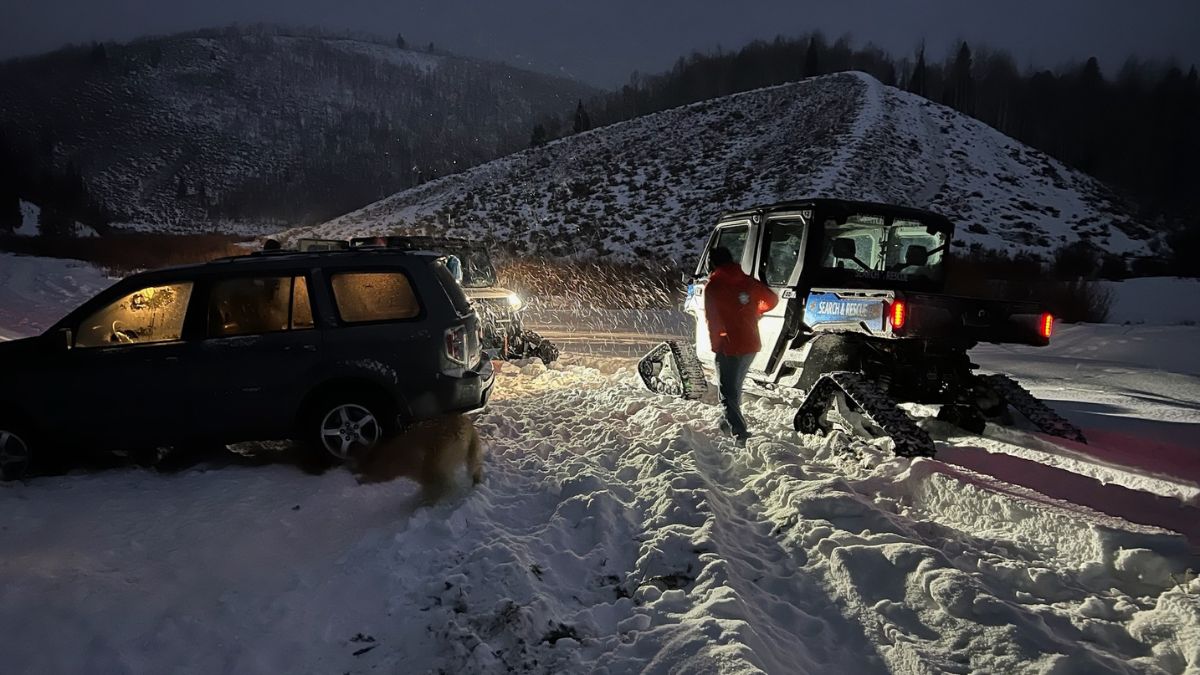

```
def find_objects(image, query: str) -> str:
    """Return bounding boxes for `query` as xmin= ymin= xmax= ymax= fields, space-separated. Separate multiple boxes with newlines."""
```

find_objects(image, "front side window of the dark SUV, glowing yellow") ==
xmin=74 ymin=281 xmax=192 ymax=348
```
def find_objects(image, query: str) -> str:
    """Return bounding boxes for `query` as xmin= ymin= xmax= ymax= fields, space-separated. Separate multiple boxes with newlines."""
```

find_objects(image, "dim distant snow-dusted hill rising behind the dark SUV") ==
xmin=0 ymin=29 xmax=593 ymax=229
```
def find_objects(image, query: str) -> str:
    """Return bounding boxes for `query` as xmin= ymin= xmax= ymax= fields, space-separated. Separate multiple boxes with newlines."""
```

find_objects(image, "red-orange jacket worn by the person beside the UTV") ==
xmin=704 ymin=263 xmax=779 ymax=357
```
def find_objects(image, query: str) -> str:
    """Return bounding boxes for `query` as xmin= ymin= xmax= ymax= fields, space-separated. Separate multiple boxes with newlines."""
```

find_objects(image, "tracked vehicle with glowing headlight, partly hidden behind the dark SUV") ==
xmin=298 ymin=235 xmax=559 ymax=365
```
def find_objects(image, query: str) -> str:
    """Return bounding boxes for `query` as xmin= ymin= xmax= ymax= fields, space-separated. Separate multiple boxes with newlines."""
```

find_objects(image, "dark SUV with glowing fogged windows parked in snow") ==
xmin=0 ymin=250 xmax=494 ymax=478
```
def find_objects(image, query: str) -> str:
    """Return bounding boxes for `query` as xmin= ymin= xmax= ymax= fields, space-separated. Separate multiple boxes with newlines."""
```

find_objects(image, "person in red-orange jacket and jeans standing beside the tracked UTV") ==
xmin=704 ymin=247 xmax=779 ymax=443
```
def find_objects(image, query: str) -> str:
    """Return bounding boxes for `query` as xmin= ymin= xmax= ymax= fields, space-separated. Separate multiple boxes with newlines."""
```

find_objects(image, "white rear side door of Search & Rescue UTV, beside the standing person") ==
xmin=750 ymin=211 xmax=811 ymax=380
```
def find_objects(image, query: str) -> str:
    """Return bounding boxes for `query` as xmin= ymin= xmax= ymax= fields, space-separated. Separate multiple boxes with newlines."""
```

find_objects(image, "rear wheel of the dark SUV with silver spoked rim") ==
xmin=301 ymin=392 xmax=396 ymax=464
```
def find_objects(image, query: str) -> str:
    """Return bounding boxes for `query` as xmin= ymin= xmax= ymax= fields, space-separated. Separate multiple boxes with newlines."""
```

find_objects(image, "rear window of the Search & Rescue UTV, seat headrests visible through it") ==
xmin=821 ymin=215 xmax=947 ymax=283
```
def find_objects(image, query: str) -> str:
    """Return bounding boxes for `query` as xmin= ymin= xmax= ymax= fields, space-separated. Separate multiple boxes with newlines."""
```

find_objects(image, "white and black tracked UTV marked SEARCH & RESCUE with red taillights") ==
xmin=638 ymin=199 xmax=1085 ymax=456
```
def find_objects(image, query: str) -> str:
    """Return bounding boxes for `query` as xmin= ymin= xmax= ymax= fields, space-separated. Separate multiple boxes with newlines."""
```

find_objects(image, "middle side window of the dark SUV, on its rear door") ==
xmin=208 ymin=276 xmax=313 ymax=338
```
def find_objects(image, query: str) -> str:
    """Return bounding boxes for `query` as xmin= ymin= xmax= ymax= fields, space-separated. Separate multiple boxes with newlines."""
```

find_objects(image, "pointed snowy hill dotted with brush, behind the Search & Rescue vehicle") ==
xmin=290 ymin=73 xmax=1154 ymax=263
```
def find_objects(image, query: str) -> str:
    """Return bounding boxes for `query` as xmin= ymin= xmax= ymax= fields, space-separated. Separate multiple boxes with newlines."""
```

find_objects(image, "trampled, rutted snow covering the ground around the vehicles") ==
xmin=0 ymin=256 xmax=1200 ymax=674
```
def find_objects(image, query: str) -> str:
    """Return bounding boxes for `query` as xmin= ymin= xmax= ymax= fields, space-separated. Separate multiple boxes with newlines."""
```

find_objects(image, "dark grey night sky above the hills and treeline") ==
xmin=0 ymin=0 xmax=1200 ymax=85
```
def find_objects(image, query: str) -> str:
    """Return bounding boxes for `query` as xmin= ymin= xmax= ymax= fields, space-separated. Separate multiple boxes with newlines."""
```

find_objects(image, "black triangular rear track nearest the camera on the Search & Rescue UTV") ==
xmin=793 ymin=371 xmax=934 ymax=456
